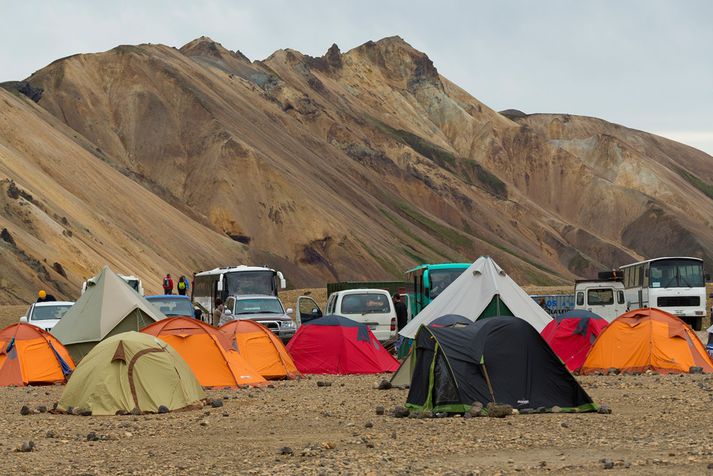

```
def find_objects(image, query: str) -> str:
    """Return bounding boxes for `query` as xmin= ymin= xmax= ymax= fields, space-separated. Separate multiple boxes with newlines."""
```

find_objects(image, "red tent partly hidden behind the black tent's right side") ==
xmin=541 ymin=309 xmax=609 ymax=372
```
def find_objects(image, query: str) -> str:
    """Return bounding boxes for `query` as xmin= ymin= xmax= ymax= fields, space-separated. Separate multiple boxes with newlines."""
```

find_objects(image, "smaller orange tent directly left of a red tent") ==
xmin=220 ymin=319 xmax=301 ymax=379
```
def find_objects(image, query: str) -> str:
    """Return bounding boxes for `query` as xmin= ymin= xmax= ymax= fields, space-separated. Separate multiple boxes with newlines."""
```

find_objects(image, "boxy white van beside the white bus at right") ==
xmin=574 ymin=280 xmax=629 ymax=322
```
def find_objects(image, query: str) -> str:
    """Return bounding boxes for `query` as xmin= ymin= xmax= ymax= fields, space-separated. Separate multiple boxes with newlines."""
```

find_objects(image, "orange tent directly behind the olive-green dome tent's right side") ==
xmin=141 ymin=317 xmax=265 ymax=387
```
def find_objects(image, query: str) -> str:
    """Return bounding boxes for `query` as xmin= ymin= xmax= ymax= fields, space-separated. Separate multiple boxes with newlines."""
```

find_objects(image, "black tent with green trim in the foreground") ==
xmin=406 ymin=316 xmax=597 ymax=413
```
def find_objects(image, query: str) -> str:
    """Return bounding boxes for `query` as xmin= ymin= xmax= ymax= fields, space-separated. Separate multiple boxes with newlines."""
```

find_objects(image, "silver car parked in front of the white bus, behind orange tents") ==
xmin=220 ymin=295 xmax=297 ymax=343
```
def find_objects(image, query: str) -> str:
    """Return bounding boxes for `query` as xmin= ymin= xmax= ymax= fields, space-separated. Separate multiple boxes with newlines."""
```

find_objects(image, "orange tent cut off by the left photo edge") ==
xmin=0 ymin=323 xmax=74 ymax=386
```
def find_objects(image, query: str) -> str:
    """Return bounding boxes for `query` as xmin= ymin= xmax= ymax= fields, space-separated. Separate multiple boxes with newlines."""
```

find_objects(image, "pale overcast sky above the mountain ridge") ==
xmin=0 ymin=0 xmax=713 ymax=155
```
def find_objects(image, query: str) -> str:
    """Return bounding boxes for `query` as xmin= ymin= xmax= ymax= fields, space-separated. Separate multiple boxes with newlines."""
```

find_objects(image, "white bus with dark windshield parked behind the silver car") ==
xmin=192 ymin=265 xmax=286 ymax=312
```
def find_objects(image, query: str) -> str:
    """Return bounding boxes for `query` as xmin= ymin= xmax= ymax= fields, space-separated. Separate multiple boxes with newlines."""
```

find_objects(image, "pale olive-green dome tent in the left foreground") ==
xmin=57 ymin=332 xmax=206 ymax=415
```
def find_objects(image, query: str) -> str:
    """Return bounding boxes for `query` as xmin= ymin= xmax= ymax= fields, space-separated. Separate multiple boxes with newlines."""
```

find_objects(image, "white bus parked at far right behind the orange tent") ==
xmin=621 ymin=257 xmax=708 ymax=331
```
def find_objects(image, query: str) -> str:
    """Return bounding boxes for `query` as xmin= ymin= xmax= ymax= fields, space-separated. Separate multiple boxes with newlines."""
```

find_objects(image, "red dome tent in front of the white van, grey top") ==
xmin=287 ymin=315 xmax=399 ymax=374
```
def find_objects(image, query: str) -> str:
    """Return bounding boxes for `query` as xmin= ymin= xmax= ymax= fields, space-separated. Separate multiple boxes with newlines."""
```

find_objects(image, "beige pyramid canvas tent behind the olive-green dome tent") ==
xmin=52 ymin=266 xmax=166 ymax=362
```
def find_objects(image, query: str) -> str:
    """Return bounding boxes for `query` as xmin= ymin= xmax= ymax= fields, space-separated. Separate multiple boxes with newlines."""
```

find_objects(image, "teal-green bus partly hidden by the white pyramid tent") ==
xmin=406 ymin=263 xmax=472 ymax=320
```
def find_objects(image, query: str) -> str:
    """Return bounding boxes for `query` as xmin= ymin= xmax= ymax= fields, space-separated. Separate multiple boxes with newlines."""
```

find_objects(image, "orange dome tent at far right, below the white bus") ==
xmin=580 ymin=308 xmax=713 ymax=374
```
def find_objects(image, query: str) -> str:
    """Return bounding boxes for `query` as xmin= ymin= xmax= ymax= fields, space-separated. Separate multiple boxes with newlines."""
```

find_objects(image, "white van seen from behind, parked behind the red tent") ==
xmin=325 ymin=289 xmax=396 ymax=342
